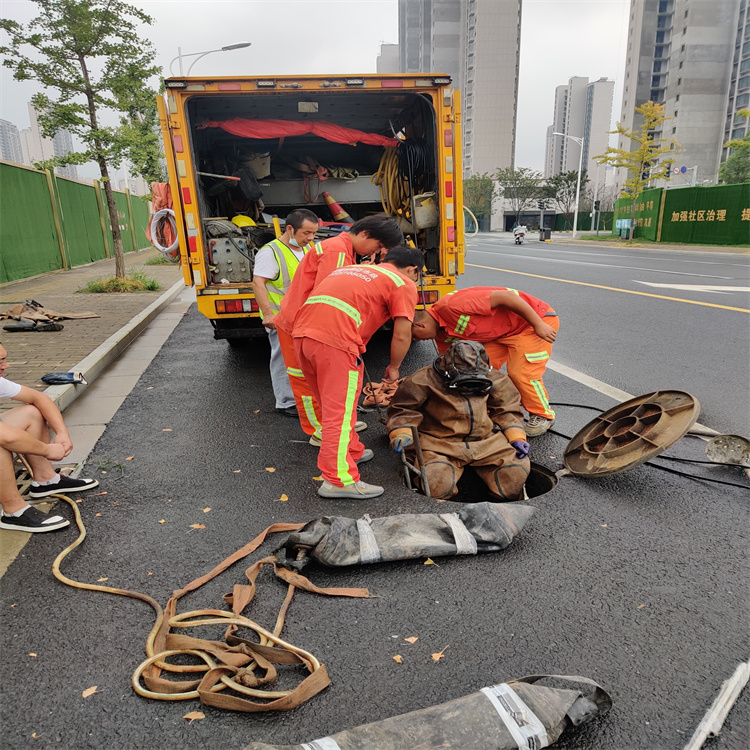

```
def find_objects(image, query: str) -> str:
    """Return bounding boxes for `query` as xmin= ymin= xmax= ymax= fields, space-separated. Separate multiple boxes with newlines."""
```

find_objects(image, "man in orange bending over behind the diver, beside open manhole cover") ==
xmin=412 ymin=286 xmax=560 ymax=437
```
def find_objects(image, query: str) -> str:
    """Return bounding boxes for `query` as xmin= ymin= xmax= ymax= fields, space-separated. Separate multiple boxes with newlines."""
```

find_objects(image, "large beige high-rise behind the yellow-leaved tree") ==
xmin=617 ymin=0 xmax=750 ymax=186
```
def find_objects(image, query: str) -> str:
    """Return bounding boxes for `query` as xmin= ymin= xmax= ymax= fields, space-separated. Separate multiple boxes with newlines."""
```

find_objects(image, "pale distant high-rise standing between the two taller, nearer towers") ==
xmin=544 ymin=76 xmax=615 ymax=182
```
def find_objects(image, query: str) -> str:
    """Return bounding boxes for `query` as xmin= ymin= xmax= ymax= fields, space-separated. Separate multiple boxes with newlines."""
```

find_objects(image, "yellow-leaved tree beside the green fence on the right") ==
xmin=594 ymin=101 xmax=680 ymax=240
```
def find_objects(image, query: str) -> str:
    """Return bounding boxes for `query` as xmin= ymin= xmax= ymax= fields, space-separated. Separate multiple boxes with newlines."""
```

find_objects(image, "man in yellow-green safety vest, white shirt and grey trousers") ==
xmin=253 ymin=208 xmax=318 ymax=417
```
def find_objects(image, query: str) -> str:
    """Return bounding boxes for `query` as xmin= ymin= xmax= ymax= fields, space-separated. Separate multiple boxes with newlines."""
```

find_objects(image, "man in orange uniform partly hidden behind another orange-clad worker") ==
xmin=274 ymin=214 xmax=404 ymax=447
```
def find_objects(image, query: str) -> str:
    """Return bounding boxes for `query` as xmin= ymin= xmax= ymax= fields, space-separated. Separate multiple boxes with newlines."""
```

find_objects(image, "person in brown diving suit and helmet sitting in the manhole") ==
xmin=388 ymin=341 xmax=530 ymax=501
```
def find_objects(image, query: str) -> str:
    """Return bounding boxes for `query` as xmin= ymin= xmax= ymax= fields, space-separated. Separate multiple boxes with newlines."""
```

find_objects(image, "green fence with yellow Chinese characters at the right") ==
xmin=615 ymin=182 xmax=750 ymax=246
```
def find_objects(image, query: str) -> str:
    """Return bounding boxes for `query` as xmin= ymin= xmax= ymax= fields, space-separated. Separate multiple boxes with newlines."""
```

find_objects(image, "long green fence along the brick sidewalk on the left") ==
xmin=0 ymin=161 xmax=149 ymax=283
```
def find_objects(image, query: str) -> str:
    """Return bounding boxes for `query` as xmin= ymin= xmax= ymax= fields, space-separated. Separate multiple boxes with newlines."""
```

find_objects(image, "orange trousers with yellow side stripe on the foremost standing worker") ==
xmin=294 ymin=336 xmax=365 ymax=487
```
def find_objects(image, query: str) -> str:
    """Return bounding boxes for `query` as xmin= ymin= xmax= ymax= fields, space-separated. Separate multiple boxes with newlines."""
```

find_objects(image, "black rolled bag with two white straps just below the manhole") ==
xmin=278 ymin=503 xmax=535 ymax=570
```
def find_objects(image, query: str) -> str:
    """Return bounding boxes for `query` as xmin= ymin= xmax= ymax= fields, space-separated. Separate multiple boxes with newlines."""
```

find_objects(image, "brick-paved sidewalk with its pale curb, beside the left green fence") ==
xmin=0 ymin=248 xmax=184 ymax=413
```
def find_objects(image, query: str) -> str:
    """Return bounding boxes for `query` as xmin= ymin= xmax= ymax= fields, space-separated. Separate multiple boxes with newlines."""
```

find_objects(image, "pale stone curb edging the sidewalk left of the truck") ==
xmin=44 ymin=280 xmax=185 ymax=411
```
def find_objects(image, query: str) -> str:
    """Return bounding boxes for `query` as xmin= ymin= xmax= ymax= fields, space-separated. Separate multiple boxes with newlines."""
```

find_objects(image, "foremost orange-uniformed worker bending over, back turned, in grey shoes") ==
xmin=292 ymin=245 xmax=423 ymax=499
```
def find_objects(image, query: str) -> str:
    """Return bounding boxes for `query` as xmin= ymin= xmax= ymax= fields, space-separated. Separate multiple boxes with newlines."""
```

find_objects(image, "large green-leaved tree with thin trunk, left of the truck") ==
xmin=0 ymin=0 xmax=160 ymax=279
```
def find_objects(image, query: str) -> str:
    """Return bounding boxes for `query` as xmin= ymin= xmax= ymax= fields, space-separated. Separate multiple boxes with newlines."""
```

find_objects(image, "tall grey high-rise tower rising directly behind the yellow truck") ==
xmin=399 ymin=0 xmax=521 ymax=176
